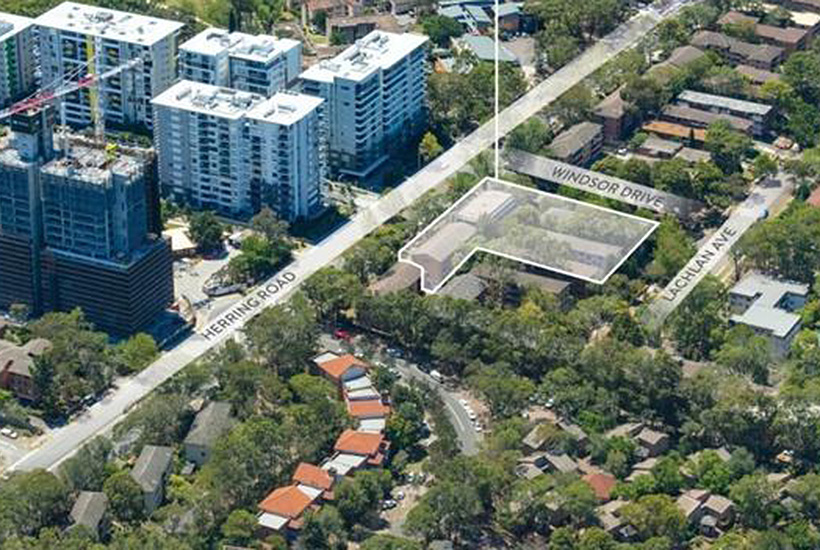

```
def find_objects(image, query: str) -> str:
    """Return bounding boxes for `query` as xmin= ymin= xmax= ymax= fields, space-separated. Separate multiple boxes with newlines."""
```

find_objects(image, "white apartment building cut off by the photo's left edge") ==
xmin=0 ymin=13 xmax=36 ymax=107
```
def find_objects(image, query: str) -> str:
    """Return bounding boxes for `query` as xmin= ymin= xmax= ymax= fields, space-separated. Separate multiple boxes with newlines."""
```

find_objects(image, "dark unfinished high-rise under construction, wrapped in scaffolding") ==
xmin=0 ymin=105 xmax=173 ymax=334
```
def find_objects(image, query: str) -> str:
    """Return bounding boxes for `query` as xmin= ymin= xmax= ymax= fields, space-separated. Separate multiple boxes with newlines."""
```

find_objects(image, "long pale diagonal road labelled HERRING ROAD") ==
xmin=10 ymin=1 xmax=684 ymax=471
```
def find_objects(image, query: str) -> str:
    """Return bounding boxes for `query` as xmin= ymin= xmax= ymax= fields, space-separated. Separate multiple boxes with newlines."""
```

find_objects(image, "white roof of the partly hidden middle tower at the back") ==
xmin=179 ymin=29 xmax=300 ymax=62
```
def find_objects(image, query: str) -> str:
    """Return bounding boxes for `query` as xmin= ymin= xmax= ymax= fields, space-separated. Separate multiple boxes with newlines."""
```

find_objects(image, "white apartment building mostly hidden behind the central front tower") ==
xmin=179 ymin=29 xmax=302 ymax=97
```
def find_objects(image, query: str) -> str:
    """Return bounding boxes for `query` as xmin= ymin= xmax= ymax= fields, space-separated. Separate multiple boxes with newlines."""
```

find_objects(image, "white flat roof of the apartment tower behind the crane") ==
xmin=35 ymin=2 xmax=184 ymax=46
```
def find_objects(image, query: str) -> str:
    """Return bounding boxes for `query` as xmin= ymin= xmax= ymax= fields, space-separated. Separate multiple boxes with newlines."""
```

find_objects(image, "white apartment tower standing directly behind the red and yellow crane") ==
xmin=35 ymin=2 xmax=183 ymax=128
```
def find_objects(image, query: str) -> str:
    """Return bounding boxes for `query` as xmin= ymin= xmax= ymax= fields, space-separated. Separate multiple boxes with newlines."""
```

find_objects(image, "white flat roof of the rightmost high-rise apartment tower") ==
xmin=301 ymin=30 xmax=428 ymax=82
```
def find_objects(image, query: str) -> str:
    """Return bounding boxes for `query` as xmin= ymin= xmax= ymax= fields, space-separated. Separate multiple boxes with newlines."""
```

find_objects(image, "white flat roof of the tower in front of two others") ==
xmin=152 ymin=80 xmax=322 ymax=125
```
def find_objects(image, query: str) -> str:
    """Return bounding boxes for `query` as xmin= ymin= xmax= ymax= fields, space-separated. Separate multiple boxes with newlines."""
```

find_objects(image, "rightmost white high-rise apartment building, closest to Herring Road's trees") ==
xmin=301 ymin=30 xmax=428 ymax=178
